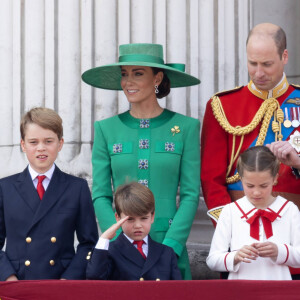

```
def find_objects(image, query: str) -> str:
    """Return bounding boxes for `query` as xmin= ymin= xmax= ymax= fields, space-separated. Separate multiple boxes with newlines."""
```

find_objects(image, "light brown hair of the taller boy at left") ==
xmin=20 ymin=107 xmax=63 ymax=141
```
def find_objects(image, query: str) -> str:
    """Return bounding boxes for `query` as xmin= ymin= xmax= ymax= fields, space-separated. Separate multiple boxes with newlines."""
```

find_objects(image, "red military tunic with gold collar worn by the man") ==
xmin=201 ymin=77 xmax=300 ymax=220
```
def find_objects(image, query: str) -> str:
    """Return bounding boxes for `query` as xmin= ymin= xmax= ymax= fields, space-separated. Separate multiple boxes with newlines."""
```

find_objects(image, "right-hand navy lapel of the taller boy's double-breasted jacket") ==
xmin=27 ymin=166 xmax=68 ymax=232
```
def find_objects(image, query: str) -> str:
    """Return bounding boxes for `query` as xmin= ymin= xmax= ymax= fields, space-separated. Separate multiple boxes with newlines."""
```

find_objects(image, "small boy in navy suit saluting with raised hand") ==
xmin=87 ymin=182 xmax=182 ymax=280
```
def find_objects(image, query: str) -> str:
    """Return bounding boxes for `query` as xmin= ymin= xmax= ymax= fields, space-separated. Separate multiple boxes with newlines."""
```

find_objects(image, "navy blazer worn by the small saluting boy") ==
xmin=87 ymin=234 xmax=182 ymax=280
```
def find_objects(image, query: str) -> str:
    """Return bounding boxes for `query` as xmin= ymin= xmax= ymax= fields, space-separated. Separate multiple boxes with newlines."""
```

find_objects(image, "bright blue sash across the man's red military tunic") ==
xmin=227 ymin=89 xmax=300 ymax=191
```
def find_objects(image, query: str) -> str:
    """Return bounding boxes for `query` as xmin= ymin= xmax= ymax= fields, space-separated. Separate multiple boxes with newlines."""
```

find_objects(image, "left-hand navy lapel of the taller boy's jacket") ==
xmin=14 ymin=167 xmax=41 ymax=213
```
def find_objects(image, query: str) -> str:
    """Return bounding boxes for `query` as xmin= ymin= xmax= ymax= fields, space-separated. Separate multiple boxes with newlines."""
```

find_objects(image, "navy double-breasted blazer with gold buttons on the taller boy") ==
xmin=0 ymin=166 xmax=98 ymax=281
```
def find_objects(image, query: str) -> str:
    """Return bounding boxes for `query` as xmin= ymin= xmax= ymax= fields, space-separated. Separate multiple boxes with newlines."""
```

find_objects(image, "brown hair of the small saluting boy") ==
xmin=115 ymin=182 xmax=155 ymax=217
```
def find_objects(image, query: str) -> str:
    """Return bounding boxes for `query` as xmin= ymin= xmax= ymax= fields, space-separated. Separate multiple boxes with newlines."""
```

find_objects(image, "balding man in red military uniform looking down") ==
xmin=201 ymin=23 xmax=300 ymax=273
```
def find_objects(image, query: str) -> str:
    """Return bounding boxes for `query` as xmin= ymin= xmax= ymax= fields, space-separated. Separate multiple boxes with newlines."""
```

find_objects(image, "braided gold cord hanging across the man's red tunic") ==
xmin=211 ymin=95 xmax=284 ymax=184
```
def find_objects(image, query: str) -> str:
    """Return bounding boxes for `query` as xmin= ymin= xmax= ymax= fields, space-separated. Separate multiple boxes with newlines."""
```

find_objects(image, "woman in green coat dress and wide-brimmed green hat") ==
xmin=82 ymin=44 xmax=200 ymax=279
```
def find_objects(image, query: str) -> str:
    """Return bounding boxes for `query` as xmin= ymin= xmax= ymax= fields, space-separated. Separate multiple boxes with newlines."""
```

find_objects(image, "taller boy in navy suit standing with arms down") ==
xmin=0 ymin=108 xmax=98 ymax=281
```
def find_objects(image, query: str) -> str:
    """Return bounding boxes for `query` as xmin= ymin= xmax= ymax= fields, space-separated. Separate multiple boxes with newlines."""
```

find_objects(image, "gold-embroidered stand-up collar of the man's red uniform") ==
xmin=248 ymin=73 xmax=289 ymax=100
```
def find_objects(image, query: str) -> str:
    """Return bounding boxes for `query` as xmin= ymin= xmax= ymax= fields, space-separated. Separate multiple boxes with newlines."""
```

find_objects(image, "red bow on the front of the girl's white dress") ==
xmin=247 ymin=209 xmax=277 ymax=241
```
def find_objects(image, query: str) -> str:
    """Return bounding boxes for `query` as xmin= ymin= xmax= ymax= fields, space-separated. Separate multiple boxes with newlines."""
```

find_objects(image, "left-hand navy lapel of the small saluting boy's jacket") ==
xmin=115 ymin=233 xmax=145 ymax=268
